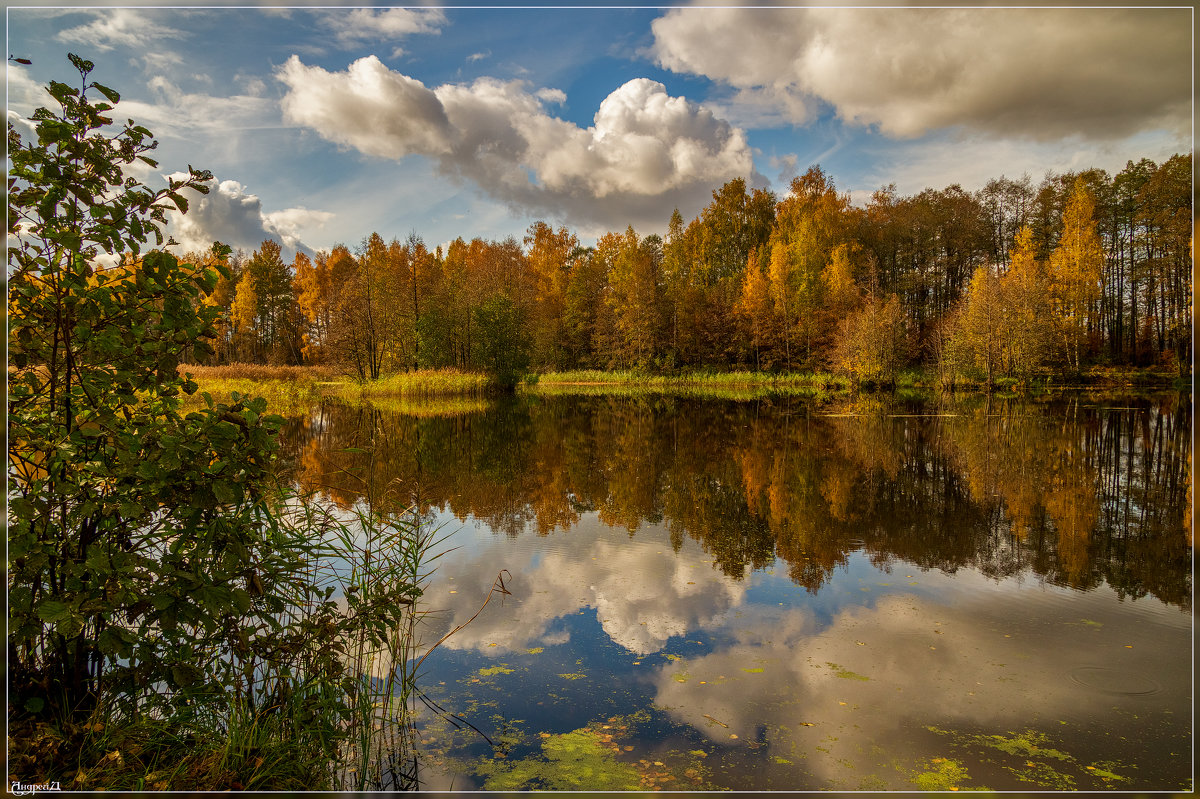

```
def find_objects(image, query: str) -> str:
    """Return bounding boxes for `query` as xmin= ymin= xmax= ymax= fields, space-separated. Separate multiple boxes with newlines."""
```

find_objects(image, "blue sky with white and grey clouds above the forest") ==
xmin=6 ymin=4 xmax=1193 ymax=254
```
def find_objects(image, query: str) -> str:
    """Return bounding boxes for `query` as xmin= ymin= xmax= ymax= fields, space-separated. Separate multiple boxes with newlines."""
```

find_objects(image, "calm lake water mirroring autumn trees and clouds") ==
xmin=278 ymin=388 xmax=1193 ymax=791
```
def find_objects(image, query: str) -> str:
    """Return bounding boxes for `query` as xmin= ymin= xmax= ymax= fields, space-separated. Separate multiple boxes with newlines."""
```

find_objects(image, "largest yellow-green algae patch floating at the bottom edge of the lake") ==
xmin=476 ymin=728 xmax=641 ymax=791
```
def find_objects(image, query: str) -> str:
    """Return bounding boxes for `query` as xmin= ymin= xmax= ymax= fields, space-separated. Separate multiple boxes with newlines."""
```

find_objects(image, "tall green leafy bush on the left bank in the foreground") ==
xmin=8 ymin=55 xmax=424 ymax=788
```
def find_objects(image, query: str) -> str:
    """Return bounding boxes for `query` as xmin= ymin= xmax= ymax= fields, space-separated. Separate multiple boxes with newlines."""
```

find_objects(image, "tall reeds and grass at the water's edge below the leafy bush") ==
xmin=10 ymin=492 xmax=444 ymax=792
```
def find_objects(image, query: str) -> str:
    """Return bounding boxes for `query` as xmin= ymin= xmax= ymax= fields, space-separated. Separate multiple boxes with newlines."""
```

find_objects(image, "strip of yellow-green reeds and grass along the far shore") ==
xmin=179 ymin=364 xmax=1192 ymax=407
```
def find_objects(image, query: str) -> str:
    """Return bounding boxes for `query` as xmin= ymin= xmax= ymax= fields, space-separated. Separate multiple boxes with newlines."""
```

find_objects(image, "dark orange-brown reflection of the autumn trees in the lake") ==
xmin=283 ymin=395 xmax=1192 ymax=604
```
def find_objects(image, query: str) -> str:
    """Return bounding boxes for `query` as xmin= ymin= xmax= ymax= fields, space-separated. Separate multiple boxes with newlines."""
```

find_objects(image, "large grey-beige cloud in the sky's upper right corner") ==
xmin=652 ymin=8 xmax=1192 ymax=139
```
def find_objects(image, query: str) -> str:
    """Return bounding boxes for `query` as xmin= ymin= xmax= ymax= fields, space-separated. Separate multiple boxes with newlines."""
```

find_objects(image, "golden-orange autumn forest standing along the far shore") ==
xmin=192 ymin=155 xmax=1192 ymax=383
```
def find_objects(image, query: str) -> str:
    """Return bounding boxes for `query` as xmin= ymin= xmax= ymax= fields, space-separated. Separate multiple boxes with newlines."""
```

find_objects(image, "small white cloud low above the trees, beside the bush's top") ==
xmin=168 ymin=174 xmax=334 ymax=258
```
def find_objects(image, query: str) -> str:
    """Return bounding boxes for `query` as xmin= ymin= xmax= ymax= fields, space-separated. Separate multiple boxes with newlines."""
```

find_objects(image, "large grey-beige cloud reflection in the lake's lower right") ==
xmin=655 ymin=568 xmax=1190 ymax=789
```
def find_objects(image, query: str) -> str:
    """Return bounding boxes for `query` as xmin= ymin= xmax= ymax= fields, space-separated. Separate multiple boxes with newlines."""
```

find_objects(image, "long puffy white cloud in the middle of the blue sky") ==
xmin=276 ymin=55 xmax=756 ymax=226
